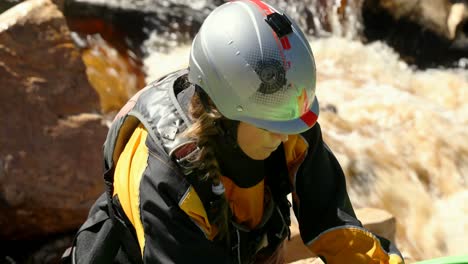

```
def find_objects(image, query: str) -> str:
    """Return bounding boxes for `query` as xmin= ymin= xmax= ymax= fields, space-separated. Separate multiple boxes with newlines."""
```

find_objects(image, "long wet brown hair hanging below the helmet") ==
xmin=177 ymin=77 xmax=231 ymax=245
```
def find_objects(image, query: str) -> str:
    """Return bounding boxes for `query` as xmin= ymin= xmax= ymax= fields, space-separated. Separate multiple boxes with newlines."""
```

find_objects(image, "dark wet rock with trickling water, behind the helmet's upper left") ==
xmin=64 ymin=0 xmax=223 ymax=54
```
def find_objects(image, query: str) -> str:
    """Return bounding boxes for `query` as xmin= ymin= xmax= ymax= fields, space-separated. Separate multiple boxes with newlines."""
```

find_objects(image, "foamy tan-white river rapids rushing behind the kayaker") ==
xmin=144 ymin=8 xmax=468 ymax=260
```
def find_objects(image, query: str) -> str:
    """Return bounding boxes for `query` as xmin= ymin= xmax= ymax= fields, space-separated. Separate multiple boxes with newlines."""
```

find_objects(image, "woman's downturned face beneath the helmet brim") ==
xmin=237 ymin=122 xmax=288 ymax=160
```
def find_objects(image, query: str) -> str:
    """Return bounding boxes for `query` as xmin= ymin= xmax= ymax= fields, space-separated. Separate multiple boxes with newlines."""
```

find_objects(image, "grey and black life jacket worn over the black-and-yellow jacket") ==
xmin=62 ymin=70 xmax=291 ymax=263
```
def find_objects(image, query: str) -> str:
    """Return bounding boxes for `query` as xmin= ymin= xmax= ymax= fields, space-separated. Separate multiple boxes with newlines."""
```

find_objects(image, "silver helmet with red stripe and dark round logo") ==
xmin=189 ymin=0 xmax=319 ymax=134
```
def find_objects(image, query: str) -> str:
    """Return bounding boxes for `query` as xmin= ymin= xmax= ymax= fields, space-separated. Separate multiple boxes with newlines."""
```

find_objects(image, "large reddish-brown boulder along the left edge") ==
xmin=0 ymin=0 xmax=107 ymax=240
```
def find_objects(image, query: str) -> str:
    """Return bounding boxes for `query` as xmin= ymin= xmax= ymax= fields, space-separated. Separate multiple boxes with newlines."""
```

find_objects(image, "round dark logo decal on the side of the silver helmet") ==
xmin=255 ymin=60 xmax=286 ymax=94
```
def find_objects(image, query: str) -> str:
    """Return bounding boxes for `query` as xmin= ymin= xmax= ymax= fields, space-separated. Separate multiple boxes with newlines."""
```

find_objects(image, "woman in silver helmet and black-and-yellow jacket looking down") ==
xmin=66 ymin=0 xmax=403 ymax=263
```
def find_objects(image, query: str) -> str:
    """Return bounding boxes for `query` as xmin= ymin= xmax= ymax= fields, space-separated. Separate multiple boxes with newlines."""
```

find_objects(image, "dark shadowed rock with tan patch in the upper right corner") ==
xmin=362 ymin=0 xmax=468 ymax=68
